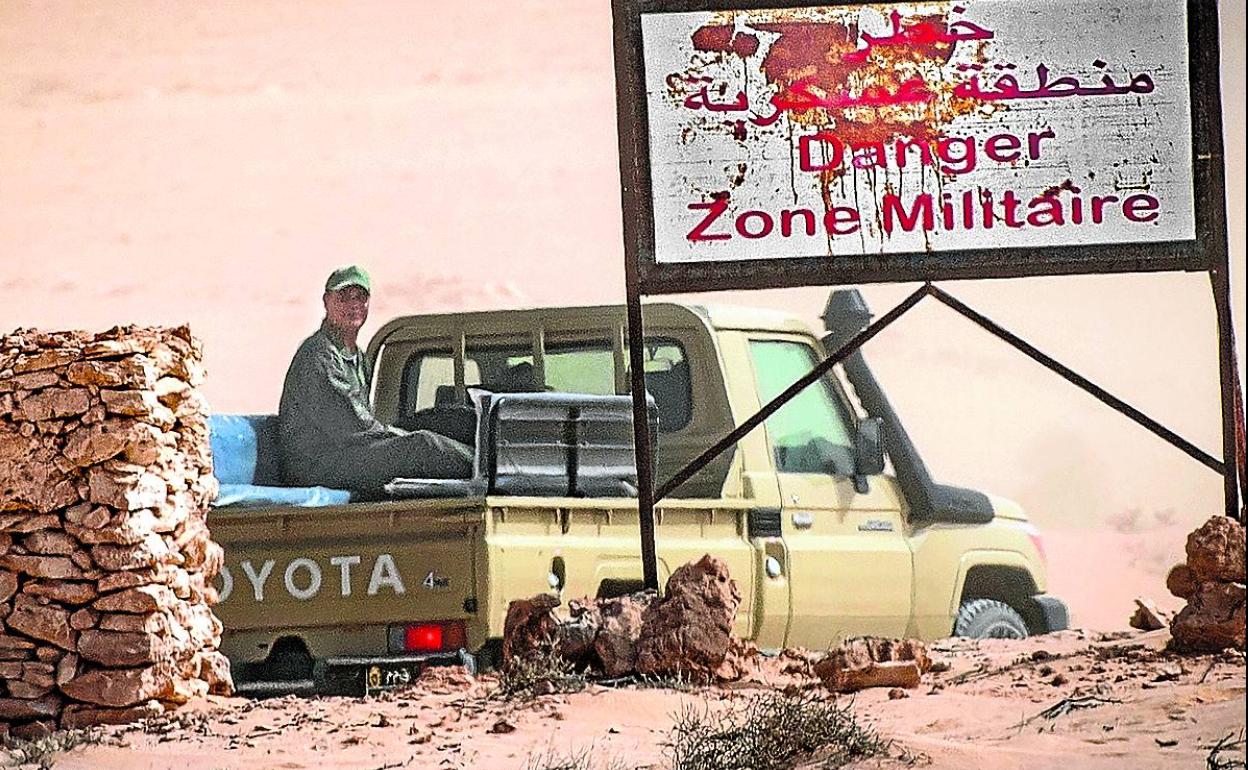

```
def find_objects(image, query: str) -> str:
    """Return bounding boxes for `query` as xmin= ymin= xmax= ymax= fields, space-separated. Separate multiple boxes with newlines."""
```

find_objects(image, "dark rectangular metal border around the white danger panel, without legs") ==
xmin=613 ymin=0 xmax=1227 ymax=295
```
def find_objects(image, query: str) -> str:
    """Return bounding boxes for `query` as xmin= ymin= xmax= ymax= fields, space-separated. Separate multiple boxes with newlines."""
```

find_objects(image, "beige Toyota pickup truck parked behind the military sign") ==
xmin=208 ymin=290 xmax=1067 ymax=693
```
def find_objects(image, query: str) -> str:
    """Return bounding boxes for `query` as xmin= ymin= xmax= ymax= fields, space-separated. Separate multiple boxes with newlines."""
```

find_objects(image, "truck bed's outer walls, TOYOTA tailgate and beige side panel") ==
xmin=210 ymin=495 xmax=760 ymax=661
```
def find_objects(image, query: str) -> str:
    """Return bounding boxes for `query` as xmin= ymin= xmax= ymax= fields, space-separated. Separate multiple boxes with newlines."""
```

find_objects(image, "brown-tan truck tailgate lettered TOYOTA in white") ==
xmin=208 ymin=499 xmax=484 ymax=658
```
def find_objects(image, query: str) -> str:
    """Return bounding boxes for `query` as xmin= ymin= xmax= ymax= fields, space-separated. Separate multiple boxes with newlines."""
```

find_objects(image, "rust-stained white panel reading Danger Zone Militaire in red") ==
xmin=640 ymin=0 xmax=1196 ymax=263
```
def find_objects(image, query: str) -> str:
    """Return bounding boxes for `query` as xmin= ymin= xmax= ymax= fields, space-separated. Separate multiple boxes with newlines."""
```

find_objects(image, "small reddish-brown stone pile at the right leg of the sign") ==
xmin=1166 ymin=515 xmax=1248 ymax=653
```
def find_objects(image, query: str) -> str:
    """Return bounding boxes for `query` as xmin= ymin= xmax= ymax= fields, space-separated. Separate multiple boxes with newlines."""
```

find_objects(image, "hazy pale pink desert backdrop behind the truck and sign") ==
xmin=0 ymin=0 xmax=1248 ymax=546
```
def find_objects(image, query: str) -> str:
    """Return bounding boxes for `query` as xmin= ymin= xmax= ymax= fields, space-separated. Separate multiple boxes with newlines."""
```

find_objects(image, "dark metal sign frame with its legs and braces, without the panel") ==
xmin=612 ymin=0 xmax=1244 ymax=588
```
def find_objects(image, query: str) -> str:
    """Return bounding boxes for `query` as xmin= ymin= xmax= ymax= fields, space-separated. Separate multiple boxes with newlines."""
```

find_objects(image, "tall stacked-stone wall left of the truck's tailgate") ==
xmin=0 ymin=327 xmax=231 ymax=736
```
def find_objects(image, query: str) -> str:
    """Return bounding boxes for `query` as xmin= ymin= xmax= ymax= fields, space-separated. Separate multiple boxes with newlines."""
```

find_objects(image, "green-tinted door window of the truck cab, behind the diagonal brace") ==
xmin=750 ymin=339 xmax=854 ymax=475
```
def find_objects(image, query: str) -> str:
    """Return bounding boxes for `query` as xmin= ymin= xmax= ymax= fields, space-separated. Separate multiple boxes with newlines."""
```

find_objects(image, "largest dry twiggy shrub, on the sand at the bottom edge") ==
xmin=669 ymin=691 xmax=891 ymax=770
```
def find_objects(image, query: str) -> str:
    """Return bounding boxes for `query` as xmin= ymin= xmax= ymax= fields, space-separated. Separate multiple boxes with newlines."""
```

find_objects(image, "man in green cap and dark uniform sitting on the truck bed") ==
xmin=278 ymin=266 xmax=472 ymax=492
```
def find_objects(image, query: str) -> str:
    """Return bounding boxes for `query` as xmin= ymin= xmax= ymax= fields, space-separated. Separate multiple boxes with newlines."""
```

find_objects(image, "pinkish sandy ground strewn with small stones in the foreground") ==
xmin=14 ymin=631 xmax=1244 ymax=770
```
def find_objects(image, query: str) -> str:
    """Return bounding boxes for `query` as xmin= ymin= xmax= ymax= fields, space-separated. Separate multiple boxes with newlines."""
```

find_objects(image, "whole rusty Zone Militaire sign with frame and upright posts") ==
xmin=614 ymin=0 xmax=1238 ymax=589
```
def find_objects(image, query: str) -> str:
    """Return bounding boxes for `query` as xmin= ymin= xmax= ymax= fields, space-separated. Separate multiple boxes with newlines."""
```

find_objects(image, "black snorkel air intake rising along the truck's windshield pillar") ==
xmin=824 ymin=288 xmax=992 ymax=524
